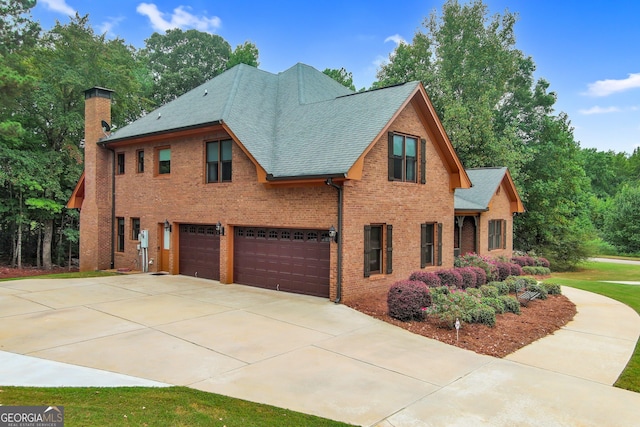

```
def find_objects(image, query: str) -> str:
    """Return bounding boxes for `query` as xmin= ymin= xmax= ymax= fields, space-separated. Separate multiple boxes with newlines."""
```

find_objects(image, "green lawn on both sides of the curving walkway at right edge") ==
xmin=545 ymin=262 xmax=640 ymax=393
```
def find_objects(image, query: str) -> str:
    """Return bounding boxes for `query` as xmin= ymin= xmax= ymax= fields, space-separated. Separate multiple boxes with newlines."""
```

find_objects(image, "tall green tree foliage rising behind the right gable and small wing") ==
xmin=374 ymin=0 xmax=591 ymax=267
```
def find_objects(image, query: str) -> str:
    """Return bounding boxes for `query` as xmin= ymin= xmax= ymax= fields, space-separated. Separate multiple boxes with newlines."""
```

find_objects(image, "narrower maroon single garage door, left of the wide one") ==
xmin=179 ymin=224 xmax=220 ymax=280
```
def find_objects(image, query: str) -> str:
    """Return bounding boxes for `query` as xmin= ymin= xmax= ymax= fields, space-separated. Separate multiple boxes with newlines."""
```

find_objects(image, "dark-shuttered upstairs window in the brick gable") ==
xmin=389 ymin=132 xmax=427 ymax=184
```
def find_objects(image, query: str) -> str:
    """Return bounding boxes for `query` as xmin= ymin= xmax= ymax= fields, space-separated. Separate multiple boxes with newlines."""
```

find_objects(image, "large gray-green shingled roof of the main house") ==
xmin=109 ymin=64 xmax=419 ymax=178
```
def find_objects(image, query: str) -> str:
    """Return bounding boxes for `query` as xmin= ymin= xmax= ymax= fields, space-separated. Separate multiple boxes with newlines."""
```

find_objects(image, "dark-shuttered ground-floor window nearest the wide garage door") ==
xmin=364 ymin=225 xmax=393 ymax=277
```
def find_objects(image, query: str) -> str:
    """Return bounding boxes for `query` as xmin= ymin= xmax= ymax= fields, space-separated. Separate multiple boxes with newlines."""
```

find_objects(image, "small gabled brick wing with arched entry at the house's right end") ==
xmin=454 ymin=167 xmax=524 ymax=258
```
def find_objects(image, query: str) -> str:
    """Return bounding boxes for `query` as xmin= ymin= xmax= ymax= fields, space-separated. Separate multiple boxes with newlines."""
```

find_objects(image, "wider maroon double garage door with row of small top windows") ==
xmin=233 ymin=227 xmax=330 ymax=298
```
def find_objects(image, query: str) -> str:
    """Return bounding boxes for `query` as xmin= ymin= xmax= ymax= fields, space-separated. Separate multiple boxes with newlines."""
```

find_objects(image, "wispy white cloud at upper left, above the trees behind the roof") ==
xmin=136 ymin=3 xmax=222 ymax=32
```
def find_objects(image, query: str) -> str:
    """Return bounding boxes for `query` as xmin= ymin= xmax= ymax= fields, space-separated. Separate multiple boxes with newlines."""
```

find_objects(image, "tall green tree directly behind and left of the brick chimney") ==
xmin=13 ymin=15 xmax=145 ymax=268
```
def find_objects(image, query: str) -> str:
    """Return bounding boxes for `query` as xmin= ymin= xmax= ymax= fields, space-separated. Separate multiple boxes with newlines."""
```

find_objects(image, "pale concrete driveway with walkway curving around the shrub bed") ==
xmin=0 ymin=274 xmax=640 ymax=427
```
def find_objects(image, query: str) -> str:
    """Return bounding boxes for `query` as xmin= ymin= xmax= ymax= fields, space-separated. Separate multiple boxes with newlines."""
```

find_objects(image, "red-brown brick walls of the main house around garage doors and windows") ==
xmin=83 ymin=95 xmax=454 ymax=301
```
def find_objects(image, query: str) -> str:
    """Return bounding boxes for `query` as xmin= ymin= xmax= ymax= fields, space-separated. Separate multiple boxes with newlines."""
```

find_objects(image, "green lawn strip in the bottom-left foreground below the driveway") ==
xmin=0 ymin=387 xmax=356 ymax=427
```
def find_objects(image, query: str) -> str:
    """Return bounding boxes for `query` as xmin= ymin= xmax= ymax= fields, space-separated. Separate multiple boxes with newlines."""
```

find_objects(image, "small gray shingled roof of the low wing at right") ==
xmin=454 ymin=167 xmax=507 ymax=211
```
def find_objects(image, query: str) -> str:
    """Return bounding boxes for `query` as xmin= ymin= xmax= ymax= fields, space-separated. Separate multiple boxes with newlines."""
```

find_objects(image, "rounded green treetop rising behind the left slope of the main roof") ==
xmin=141 ymin=29 xmax=232 ymax=105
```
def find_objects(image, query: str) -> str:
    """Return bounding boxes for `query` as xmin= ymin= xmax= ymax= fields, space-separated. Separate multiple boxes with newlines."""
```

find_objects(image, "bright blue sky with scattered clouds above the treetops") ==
xmin=32 ymin=0 xmax=640 ymax=153
